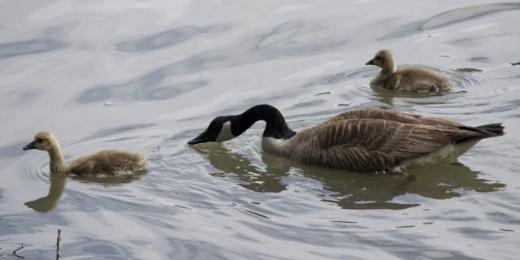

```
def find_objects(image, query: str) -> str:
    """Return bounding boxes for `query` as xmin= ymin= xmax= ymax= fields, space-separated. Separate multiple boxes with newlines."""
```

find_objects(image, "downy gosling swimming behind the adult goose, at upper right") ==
xmin=366 ymin=50 xmax=452 ymax=93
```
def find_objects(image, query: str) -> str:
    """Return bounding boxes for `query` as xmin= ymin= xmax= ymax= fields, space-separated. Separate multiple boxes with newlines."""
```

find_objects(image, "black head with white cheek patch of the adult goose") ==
xmin=188 ymin=116 xmax=237 ymax=145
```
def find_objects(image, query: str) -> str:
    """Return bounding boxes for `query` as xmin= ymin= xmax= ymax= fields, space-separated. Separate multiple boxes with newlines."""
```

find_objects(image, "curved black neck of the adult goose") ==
xmin=232 ymin=105 xmax=296 ymax=139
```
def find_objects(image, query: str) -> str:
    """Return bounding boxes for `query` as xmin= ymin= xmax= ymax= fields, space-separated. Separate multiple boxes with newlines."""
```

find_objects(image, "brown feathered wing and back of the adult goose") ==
xmin=294 ymin=119 xmax=478 ymax=171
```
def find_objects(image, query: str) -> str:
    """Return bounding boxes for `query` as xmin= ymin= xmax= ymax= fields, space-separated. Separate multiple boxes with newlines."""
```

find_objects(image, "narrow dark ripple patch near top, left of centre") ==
xmin=115 ymin=25 xmax=231 ymax=52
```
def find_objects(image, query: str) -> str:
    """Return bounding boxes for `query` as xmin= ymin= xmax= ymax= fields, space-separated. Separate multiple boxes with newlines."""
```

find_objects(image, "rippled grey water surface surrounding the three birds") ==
xmin=0 ymin=0 xmax=520 ymax=259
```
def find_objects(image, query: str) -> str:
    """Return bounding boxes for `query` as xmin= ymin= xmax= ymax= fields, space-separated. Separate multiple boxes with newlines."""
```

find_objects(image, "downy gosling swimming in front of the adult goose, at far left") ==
xmin=23 ymin=131 xmax=148 ymax=178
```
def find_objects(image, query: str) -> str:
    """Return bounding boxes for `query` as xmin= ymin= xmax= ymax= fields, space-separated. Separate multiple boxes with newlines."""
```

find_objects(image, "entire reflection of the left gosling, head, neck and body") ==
xmin=24 ymin=173 xmax=145 ymax=213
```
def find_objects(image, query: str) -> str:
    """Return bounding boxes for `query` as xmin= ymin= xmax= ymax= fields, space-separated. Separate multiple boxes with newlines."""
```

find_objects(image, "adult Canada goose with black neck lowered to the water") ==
xmin=188 ymin=105 xmax=504 ymax=173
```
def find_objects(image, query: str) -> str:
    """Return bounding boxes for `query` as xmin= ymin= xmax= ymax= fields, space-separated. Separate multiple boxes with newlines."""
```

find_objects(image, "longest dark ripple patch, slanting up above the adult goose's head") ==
xmin=77 ymin=21 xmax=349 ymax=103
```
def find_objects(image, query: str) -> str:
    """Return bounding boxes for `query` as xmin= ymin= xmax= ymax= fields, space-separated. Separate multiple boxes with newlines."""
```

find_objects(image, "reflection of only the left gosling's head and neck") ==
xmin=24 ymin=175 xmax=67 ymax=213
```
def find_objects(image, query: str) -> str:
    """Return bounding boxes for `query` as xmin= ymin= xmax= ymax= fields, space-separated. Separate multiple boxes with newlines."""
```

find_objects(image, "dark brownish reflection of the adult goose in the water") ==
xmin=193 ymin=144 xmax=505 ymax=210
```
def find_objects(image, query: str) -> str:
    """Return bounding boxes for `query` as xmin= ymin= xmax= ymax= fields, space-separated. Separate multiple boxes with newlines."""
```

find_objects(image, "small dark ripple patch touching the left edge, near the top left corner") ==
xmin=0 ymin=39 xmax=68 ymax=60
